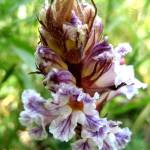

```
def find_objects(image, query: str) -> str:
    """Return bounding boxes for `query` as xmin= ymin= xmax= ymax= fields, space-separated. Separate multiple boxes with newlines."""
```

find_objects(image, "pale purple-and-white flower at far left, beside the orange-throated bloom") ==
xmin=19 ymin=90 xmax=56 ymax=140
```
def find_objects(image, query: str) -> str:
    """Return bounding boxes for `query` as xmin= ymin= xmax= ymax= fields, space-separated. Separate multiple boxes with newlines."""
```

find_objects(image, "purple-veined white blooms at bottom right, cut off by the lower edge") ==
xmin=72 ymin=120 xmax=131 ymax=150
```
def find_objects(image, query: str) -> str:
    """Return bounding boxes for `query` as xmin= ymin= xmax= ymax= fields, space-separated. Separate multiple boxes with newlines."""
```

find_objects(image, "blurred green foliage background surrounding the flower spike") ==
xmin=0 ymin=0 xmax=150 ymax=150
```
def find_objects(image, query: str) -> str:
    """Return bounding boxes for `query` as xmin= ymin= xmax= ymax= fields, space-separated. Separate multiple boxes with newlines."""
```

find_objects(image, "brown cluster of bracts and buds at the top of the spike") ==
xmin=39 ymin=0 xmax=99 ymax=64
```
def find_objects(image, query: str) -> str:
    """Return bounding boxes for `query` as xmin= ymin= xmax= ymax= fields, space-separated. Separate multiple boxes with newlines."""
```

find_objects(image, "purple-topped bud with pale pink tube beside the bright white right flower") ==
xmin=81 ymin=39 xmax=116 ymax=95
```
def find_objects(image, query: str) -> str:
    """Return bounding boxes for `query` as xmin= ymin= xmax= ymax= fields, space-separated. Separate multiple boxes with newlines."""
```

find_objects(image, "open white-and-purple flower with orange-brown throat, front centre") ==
xmin=49 ymin=84 xmax=101 ymax=141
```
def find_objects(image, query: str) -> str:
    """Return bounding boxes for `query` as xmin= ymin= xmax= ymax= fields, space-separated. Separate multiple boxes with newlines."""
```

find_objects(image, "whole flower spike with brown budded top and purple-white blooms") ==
xmin=19 ymin=0 xmax=146 ymax=150
